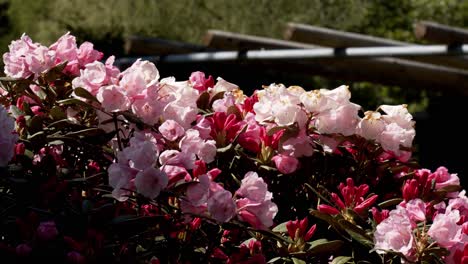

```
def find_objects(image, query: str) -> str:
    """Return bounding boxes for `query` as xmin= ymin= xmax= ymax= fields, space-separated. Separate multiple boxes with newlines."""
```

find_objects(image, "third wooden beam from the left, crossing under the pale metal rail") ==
xmin=284 ymin=23 xmax=468 ymax=69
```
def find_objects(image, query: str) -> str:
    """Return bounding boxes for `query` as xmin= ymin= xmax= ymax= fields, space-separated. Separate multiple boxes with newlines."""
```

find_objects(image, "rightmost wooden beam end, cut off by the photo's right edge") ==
xmin=413 ymin=21 xmax=468 ymax=44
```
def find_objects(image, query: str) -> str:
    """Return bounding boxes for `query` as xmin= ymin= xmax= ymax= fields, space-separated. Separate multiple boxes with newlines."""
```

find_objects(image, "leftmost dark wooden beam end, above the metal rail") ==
xmin=125 ymin=36 xmax=207 ymax=56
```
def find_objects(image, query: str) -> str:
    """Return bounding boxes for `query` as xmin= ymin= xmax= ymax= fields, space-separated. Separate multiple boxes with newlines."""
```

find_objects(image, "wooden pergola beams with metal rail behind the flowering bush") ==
xmin=119 ymin=21 xmax=468 ymax=95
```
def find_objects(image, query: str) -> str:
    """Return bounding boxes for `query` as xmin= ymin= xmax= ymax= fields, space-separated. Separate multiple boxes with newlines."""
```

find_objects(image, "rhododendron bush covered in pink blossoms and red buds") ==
xmin=0 ymin=34 xmax=468 ymax=263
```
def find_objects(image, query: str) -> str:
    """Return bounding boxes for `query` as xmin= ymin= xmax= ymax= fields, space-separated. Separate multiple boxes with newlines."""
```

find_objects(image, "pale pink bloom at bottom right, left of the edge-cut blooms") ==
xmin=374 ymin=206 xmax=415 ymax=260
